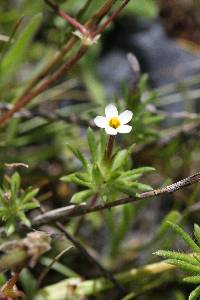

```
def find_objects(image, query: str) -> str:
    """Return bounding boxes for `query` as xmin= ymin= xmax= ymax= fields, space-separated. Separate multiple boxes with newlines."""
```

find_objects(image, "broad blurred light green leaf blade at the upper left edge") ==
xmin=0 ymin=14 xmax=42 ymax=80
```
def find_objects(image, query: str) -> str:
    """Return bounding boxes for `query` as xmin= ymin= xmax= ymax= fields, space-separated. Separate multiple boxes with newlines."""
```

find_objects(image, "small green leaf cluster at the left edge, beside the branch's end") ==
xmin=0 ymin=173 xmax=39 ymax=235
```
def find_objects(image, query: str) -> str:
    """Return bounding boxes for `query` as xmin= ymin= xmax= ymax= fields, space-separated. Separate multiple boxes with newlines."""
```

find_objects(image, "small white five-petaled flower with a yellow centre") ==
xmin=94 ymin=104 xmax=133 ymax=135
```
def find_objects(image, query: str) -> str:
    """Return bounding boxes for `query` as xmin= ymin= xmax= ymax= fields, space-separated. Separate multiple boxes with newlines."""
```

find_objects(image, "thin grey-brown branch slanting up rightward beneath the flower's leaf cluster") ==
xmin=32 ymin=172 xmax=200 ymax=226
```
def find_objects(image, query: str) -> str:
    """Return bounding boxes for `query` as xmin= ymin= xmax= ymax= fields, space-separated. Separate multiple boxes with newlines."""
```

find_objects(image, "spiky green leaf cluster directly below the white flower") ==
xmin=61 ymin=128 xmax=154 ymax=203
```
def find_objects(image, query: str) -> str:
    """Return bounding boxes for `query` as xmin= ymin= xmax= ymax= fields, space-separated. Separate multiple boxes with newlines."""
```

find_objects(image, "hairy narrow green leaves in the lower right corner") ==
xmin=155 ymin=222 xmax=200 ymax=300
